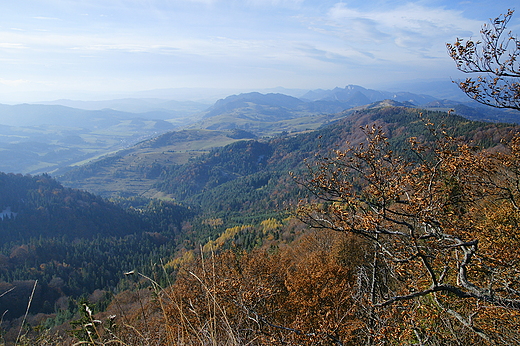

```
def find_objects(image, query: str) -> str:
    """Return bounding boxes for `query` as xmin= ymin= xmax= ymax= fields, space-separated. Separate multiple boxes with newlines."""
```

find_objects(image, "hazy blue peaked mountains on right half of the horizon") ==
xmin=190 ymin=85 xmax=520 ymax=136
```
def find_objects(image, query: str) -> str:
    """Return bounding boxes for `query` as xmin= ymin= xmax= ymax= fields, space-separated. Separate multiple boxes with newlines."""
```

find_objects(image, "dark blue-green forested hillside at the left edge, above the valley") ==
xmin=0 ymin=173 xmax=144 ymax=242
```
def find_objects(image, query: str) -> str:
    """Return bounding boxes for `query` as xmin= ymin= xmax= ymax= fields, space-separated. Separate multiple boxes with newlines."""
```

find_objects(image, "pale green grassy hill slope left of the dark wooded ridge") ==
xmin=60 ymin=129 xmax=255 ymax=197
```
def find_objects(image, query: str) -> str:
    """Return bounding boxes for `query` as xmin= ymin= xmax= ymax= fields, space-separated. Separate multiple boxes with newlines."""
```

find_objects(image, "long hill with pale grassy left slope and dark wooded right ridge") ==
xmin=60 ymin=100 xmax=509 ymax=203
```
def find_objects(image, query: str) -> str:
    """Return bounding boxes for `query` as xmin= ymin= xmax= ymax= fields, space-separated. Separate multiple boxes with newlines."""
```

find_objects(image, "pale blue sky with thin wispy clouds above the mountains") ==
xmin=0 ymin=0 xmax=520 ymax=103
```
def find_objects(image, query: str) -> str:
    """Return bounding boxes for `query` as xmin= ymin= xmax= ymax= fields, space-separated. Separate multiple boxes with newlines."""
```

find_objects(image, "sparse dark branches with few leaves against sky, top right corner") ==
xmin=446 ymin=10 xmax=520 ymax=110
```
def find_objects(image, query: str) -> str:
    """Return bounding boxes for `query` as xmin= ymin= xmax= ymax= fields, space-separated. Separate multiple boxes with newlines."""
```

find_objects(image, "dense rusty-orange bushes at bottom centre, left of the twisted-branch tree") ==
xmin=156 ymin=232 xmax=364 ymax=345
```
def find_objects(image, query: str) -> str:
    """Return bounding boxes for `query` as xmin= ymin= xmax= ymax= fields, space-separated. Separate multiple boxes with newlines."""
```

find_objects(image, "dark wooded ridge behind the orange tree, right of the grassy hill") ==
xmin=156 ymin=107 xmax=514 ymax=216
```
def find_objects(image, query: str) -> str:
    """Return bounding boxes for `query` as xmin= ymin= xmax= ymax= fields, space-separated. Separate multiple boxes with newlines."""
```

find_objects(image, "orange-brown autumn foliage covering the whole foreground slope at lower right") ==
xmin=43 ymin=124 xmax=520 ymax=345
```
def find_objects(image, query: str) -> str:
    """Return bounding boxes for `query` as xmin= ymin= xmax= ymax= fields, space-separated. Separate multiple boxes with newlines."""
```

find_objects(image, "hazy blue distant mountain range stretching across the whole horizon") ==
xmin=0 ymin=85 xmax=520 ymax=174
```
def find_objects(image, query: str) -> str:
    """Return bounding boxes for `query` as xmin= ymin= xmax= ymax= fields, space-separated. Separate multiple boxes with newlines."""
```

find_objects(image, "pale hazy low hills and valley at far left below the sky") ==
xmin=0 ymin=104 xmax=203 ymax=174
